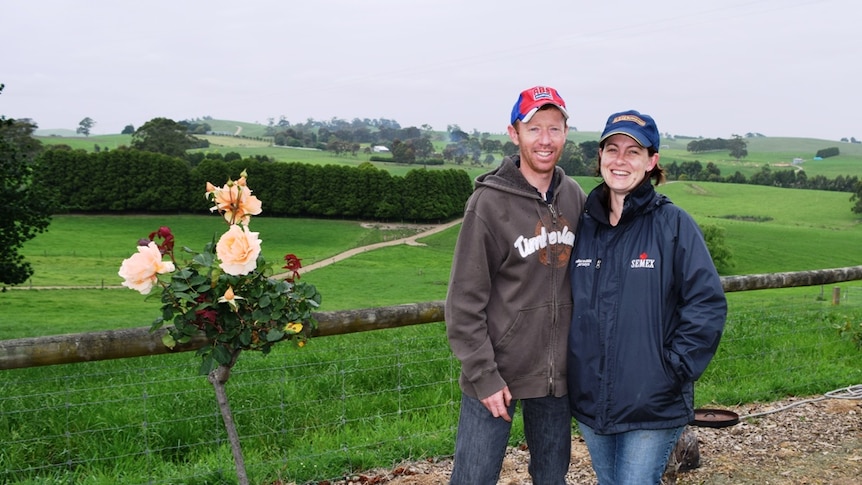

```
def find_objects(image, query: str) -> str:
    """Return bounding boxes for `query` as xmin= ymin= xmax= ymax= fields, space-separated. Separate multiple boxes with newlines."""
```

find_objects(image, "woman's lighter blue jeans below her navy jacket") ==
xmin=578 ymin=421 xmax=685 ymax=485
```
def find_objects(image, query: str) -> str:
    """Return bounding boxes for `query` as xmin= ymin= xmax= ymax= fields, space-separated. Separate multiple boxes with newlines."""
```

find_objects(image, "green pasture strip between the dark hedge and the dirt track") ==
xmin=21 ymin=215 xmax=424 ymax=287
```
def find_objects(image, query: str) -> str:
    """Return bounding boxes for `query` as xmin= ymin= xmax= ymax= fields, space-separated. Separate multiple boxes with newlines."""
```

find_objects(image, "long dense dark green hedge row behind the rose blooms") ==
xmin=34 ymin=150 xmax=473 ymax=222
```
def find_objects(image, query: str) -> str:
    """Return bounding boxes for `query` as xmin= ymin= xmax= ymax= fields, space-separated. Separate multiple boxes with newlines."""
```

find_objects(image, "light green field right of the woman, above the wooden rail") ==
xmin=659 ymin=182 xmax=862 ymax=274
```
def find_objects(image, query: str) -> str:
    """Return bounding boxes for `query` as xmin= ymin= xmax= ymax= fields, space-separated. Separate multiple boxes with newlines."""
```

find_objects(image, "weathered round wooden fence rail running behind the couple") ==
xmin=0 ymin=266 xmax=862 ymax=370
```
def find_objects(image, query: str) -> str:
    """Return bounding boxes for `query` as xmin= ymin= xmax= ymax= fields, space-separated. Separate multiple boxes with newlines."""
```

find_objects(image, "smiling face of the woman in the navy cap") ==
xmin=599 ymin=134 xmax=659 ymax=195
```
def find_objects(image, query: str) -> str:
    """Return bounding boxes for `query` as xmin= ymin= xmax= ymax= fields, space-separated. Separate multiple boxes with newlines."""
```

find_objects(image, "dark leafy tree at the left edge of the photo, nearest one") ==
xmin=0 ymin=84 xmax=51 ymax=290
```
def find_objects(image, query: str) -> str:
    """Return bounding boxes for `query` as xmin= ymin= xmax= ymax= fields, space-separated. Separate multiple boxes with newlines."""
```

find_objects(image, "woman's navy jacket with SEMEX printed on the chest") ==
xmin=568 ymin=179 xmax=727 ymax=434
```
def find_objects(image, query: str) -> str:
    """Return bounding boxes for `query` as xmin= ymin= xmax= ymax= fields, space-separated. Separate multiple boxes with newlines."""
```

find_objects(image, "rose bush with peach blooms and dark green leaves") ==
xmin=119 ymin=172 xmax=321 ymax=374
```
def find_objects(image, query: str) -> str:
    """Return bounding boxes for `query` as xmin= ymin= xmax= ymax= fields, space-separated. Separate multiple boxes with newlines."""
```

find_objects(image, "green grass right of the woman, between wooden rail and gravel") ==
xmin=697 ymin=285 xmax=862 ymax=406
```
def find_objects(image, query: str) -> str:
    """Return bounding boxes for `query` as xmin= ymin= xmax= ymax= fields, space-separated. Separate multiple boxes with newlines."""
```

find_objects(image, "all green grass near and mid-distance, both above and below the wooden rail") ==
xmin=0 ymin=163 xmax=862 ymax=485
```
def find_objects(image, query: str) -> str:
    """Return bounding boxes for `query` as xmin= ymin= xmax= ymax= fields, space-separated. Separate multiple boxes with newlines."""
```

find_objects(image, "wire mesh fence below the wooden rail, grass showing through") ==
xmin=0 ymin=286 xmax=862 ymax=484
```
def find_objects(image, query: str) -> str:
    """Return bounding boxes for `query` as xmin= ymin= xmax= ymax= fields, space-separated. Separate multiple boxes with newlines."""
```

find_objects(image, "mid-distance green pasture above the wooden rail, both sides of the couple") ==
xmin=8 ymin=178 xmax=862 ymax=338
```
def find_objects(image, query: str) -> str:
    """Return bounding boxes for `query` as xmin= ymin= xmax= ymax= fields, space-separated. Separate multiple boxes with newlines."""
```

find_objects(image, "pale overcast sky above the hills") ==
xmin=0 ymin=0 xmax=862 ymax=140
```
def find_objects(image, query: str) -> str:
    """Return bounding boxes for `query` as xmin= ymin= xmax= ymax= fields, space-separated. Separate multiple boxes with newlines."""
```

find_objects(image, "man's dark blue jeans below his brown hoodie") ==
xmin=449 ymin=394 xmax=572 ymax=485
